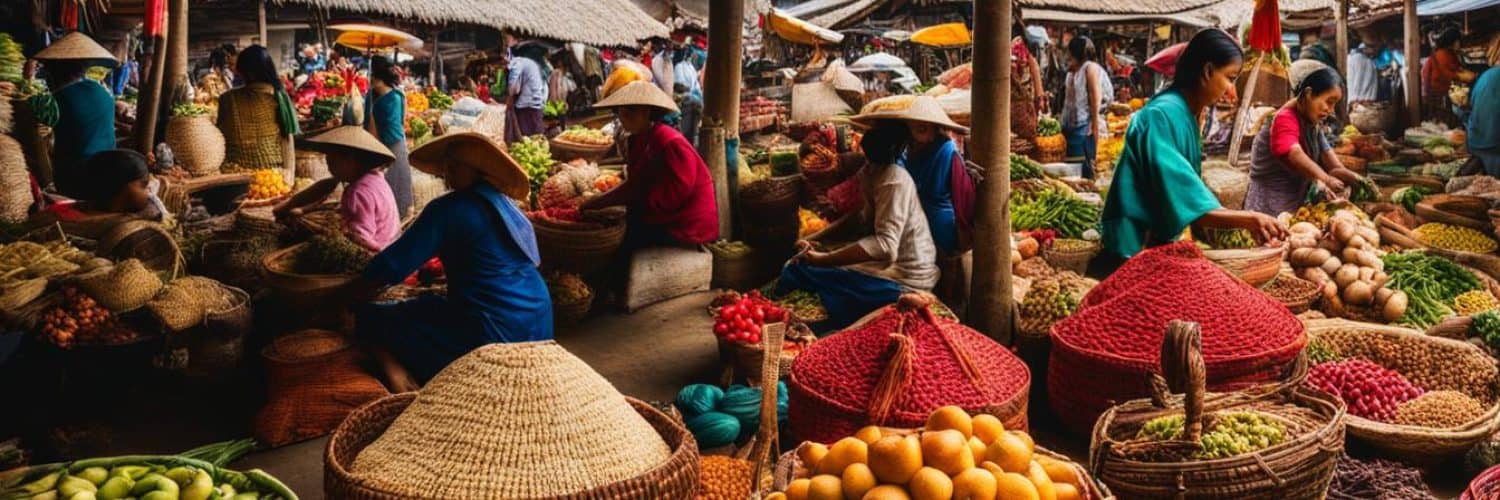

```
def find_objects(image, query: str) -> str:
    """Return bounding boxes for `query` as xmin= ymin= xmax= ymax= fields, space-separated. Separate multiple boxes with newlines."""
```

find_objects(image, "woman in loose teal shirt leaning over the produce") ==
xmin=1092 ymin=29 xmax=1287 ymax=275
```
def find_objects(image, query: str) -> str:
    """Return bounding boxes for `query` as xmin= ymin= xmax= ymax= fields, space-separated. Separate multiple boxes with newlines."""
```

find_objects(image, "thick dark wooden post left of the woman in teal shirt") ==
xmin=969 ymin=0 xmax=1013 ymax=339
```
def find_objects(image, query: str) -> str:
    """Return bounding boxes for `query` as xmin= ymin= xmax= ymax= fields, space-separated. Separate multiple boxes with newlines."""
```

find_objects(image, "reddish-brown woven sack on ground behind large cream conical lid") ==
xmin=254 ymin=330 xmax=390 ymax=446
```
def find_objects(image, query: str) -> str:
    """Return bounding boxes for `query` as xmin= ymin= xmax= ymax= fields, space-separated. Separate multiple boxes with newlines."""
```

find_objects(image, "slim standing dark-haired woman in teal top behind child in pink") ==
xmin=365 ymin=56 xmax=413 ymax=219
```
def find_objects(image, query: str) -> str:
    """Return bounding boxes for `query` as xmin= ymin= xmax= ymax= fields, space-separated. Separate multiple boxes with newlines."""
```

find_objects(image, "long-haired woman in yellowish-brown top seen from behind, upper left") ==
xmin=219 ymin=45 xmax=302 ymax=173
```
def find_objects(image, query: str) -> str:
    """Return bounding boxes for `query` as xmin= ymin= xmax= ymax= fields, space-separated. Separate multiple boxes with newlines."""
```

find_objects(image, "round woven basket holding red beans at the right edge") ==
xmin=1308 ymin=320 xmax=1500 ymax=467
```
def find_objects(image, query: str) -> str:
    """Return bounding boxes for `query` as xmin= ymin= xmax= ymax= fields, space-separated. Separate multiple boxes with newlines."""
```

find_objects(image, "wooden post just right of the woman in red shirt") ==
xmin=698 ymin=0 xmax=746 ymax=239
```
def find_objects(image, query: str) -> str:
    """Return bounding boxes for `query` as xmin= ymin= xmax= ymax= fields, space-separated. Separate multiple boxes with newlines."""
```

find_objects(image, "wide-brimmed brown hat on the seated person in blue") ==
xmin=408 ymin=132 xmax=531 ymax=200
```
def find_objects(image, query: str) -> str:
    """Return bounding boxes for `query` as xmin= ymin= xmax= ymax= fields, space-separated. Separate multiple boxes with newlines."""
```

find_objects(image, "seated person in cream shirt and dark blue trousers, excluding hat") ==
xmin=776 ymin=126 xmax=938 ymax=327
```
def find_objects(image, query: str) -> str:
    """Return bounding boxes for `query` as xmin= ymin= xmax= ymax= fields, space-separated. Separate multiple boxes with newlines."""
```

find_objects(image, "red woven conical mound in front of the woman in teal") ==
xmin=1052 ymin=242 xmax=1307 ymax=366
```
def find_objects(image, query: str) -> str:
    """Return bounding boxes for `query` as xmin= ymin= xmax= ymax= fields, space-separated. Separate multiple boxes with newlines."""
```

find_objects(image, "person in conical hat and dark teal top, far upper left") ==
xmin=36 ymin=32 xmax=116 ymax=198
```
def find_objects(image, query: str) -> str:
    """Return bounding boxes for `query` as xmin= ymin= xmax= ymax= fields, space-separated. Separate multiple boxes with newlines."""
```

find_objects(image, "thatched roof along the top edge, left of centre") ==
xmin=273 ymin=0 xmax=669 ymax=45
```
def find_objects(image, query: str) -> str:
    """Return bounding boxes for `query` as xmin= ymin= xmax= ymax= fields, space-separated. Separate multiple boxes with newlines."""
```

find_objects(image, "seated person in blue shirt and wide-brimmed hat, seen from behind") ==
xmin=342 ymin=132 xmax=552 ymax=392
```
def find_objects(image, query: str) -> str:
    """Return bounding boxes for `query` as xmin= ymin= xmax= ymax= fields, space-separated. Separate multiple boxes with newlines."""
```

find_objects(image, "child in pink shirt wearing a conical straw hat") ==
xmin=275 ymin=126 xmax=401 ymax=252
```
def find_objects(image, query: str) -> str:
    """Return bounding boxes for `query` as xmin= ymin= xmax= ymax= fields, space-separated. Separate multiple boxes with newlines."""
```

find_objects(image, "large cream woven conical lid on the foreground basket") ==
xmin=351 ymin=341 xmax=671 ymax=498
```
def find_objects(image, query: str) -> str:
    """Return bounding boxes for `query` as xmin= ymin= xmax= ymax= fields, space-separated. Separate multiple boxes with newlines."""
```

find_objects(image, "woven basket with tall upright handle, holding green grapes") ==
xmin=1089 ymin=321 xmax=1344 ymax=500
